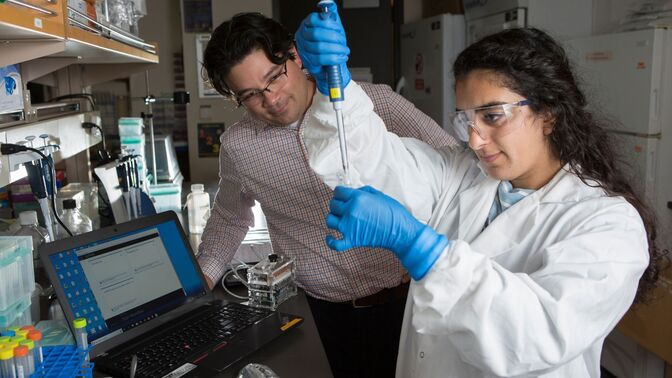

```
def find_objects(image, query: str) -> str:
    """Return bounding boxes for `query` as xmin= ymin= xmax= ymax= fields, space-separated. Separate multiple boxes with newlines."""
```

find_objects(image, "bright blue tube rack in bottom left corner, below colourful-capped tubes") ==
xmin=31 ymin=345 xmax=93 ymax=378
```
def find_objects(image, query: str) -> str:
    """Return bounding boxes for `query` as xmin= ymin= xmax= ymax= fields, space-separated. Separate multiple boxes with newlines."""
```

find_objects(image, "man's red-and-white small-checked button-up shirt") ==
xmin=198 ymin=83 xmax=456 ymax=302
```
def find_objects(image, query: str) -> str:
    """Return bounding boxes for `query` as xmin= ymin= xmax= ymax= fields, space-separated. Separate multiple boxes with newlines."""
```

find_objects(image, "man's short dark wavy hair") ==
xmin=203 ymin=13 xmax=295 ymax=97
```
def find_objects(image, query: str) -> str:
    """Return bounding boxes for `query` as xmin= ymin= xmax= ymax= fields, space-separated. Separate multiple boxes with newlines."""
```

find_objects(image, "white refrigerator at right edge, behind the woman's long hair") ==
xmin=566 ymin=29 xmax=672 ymax=250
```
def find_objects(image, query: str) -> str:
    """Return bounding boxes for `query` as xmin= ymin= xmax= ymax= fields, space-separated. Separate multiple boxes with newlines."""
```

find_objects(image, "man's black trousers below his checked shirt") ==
xmin=306 ymin=290 xmax=406 ymax=378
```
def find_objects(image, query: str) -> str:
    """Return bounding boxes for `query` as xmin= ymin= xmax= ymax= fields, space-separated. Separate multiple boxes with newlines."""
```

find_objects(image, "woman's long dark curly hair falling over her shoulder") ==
xmin=453 ymin=28 xmax=667 ymax=303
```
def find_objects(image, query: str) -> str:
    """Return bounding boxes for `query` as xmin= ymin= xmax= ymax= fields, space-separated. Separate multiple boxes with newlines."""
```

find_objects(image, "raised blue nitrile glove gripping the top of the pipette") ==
xmin=295 ymin=3 xmax=350 ymax=95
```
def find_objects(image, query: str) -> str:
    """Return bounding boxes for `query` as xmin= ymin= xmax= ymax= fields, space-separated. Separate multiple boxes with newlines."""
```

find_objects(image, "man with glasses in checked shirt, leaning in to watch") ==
xmin=198 ymin=13 xmax=455 ymax=377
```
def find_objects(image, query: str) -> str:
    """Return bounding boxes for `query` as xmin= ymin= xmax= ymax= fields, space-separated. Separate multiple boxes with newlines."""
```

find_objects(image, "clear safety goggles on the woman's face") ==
xmin=450 ymin=100 xmax=530 ymax=142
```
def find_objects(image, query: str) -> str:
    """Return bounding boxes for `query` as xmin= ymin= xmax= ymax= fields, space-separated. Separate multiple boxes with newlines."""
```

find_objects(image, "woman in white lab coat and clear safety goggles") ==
xmin=304 ymin=25 xmax=662 ymax=377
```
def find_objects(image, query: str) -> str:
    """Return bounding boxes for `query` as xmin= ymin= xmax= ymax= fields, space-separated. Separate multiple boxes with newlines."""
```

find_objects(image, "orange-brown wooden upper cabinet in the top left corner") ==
xmin=0 ymin=0 xmax=159 ymax=67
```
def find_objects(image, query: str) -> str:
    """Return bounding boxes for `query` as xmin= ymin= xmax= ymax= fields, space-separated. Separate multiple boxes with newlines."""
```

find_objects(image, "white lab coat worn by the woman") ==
xmin=304 ymin=83 xmax=648 ymax=378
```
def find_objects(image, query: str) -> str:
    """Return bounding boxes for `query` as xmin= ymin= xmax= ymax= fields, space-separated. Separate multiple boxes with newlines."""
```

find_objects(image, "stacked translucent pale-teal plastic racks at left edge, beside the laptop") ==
xmin=0 ymin=236 xmax=35 ymax=328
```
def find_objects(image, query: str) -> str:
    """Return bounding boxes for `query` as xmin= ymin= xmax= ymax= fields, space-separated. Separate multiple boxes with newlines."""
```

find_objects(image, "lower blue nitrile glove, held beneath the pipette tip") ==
xmin=326 ymin=186 xmax=448 ymax=281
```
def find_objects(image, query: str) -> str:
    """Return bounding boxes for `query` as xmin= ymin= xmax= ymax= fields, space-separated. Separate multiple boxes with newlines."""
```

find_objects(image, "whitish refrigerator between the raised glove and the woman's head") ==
xmin=397 ymin=13 xmax=466 ymax=134
